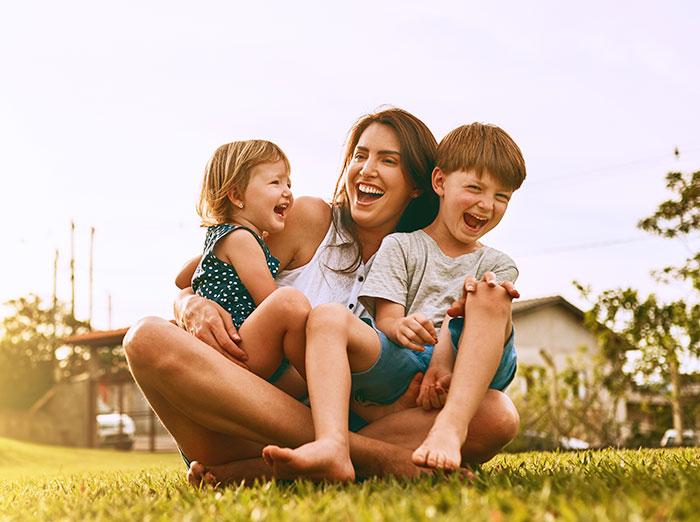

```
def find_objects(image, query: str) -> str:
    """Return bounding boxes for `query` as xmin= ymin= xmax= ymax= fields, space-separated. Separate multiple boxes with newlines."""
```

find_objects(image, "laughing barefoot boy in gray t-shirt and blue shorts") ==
xmin=263 ymin=123 xmax=525 ymax=480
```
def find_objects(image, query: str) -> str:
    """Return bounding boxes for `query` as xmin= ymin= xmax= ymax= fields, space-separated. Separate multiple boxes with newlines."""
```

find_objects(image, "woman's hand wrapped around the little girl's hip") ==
xmin=175 ymin=288 xmax=248 ymax=369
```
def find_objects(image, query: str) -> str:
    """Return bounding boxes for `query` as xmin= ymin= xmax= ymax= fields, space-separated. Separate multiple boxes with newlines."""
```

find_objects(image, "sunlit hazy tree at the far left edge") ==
xmin=0 ymin=294 xmax=89 ymax=409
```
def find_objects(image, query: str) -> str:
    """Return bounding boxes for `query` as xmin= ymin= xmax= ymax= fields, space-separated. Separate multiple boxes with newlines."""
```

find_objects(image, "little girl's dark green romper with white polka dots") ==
xmin=192 ymin=223 xmax=280 ymax=328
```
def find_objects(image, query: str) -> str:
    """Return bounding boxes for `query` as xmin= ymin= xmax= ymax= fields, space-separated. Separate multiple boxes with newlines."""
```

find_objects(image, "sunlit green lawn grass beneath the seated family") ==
xmin=0 ymin=439 xmax=700 ymax=521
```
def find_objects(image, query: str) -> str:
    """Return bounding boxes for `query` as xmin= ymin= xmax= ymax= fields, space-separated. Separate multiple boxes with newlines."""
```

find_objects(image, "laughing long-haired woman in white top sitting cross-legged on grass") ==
xmin=124 ymin=109 xmax=519 ymax=483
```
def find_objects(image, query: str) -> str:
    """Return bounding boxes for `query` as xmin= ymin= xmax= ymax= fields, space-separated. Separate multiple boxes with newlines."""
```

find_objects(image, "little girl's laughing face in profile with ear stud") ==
xmin=230 ymin=161 xmax=294 ymax=234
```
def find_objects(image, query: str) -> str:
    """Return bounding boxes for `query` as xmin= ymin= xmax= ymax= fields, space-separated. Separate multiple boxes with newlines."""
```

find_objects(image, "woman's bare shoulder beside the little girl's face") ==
xmin=267 ymin=196 xmax=331 ymax=269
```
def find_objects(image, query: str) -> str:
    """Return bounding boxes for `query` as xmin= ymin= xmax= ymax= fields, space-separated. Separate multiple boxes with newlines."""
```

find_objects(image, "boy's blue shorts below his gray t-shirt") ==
xmin=351 ymin=317 xmax=517 ymax=404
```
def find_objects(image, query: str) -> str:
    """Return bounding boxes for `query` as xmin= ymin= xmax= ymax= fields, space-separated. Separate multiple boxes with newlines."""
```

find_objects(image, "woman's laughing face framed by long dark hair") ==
xmin=345 ymin=123 xmax=418 ymax=230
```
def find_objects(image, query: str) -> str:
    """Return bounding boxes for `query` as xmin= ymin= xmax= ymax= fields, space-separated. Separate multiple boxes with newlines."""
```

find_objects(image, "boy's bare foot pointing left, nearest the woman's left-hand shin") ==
xmin=263 ymin=439 xmax=355 ymax=482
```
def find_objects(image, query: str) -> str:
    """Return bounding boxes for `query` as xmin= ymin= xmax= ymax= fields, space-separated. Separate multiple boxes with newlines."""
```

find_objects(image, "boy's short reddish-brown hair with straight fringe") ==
xmin=437 ymin=122 xmax=525 ymax=190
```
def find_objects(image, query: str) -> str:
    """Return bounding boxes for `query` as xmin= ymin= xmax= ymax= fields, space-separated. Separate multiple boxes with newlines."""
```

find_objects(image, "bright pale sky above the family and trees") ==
xmin=0 ymin=0 xmax=700 ymax=334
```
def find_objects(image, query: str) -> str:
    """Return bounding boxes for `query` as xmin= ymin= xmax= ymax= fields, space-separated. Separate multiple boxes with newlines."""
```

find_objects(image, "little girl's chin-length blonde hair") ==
xmin=197 ymin=140 xmax=290 ymax=227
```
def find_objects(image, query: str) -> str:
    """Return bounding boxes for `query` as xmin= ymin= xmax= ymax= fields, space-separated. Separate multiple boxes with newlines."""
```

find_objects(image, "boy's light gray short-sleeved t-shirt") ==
xmin=359 ymin=230 xmax=518 ymax=328
